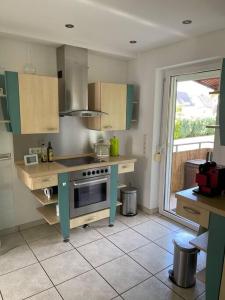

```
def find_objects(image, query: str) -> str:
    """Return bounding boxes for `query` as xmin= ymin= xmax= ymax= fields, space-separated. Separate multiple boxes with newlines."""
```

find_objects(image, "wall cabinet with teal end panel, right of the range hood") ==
xmin=87 ymin=82 xmax=134 ymax=131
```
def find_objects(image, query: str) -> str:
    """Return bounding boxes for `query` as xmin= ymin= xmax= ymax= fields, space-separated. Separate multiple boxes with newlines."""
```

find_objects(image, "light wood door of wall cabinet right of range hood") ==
xmin=101 ymin=82 xmax=127 ymax=130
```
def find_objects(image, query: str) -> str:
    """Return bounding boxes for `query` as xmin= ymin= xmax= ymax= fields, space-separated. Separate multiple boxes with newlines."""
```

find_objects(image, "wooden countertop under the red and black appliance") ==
xmin=175 ymin=188 xmax=225 ymax=217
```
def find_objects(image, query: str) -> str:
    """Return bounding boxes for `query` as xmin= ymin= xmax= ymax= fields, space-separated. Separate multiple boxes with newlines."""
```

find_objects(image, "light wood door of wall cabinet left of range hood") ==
xmin=19 ymin=74 xmax=59 ymax=134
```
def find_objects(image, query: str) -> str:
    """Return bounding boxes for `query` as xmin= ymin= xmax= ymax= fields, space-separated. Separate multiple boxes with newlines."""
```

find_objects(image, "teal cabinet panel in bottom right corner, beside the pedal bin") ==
xmin=206 ymin=214 xmax=225 ymax=300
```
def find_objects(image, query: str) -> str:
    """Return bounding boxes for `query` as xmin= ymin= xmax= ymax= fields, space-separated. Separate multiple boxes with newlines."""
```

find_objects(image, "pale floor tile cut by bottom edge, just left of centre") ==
xmin=57 ymin=270 xmax=117 ymax=300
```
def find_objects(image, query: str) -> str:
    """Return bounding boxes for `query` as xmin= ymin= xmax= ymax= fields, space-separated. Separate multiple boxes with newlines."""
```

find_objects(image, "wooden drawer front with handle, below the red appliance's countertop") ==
xmin=176 ymin=199 xmax=209 ymax=228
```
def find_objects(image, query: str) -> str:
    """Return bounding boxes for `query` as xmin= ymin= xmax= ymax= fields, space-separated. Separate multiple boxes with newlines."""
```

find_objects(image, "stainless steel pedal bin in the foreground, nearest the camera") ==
xmin=169 ymin=240 xmax=199 ymax=288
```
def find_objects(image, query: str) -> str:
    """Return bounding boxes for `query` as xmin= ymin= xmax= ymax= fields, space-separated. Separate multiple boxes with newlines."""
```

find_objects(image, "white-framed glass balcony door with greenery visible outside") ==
xmin=160 ymin=70 xmax=220 ymax=223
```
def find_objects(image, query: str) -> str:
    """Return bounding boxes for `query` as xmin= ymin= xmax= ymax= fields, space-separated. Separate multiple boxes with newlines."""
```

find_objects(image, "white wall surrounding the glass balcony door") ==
xmin=124 ymin=30 xmax=225 ymax=209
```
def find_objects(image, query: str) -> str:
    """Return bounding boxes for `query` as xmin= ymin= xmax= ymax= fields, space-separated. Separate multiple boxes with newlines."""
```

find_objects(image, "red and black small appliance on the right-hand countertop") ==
xmin=194 ymin=161 xmax=225 ymax=197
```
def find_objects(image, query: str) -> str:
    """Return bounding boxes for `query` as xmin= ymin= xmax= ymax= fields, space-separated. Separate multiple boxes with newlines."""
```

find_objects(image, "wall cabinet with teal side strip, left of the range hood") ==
xmin=5 ymin=71 xmax=59 ymax=134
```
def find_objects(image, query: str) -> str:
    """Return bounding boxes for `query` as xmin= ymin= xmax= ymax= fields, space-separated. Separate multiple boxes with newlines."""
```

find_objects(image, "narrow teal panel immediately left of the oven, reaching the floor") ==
xmin=58 ymin=173 xmax=70 ymax=242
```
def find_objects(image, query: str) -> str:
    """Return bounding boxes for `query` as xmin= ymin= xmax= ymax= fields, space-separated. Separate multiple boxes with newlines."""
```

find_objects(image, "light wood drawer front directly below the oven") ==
xmin=70 ymin=209 xmax=110 ymax=228
